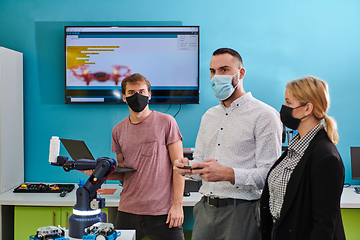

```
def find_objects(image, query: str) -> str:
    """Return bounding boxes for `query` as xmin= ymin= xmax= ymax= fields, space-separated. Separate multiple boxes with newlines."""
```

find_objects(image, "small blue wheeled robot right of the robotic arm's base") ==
xmin=82 ymin=222 xmax=121 ymax=240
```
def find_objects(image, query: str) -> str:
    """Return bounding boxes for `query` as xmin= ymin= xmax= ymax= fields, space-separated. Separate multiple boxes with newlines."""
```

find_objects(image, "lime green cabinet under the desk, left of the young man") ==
xmin=14 ymin=206 xmax=108 ymax=240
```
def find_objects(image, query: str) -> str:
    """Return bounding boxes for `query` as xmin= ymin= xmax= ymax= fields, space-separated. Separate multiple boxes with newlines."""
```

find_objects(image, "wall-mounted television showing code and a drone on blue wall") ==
xmin=65 ymin=26 xmax=199 ymax=104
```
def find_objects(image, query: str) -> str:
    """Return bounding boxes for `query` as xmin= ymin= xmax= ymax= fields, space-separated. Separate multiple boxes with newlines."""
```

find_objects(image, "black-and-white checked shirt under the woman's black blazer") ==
xmin=268 ymin=123 xmax=323 ymax=219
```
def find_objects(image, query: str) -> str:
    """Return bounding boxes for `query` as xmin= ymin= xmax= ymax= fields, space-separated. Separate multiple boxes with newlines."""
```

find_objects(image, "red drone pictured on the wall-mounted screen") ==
xmin=70 ymin=65 xmax=131 ymax=85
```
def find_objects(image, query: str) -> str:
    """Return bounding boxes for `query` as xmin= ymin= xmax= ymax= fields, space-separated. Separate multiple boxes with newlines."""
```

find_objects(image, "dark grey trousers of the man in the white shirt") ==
xmin=191 ymin=199 xmax=260 ymax=240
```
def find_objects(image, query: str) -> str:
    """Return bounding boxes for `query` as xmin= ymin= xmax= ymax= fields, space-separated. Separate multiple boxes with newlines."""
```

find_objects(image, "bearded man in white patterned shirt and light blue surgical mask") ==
xmin=174 ymin=48 xmax=282 ymax=240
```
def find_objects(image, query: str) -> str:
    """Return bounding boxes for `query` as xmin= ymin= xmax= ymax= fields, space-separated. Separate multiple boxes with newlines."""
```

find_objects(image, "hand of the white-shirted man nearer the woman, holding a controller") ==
xmin=191 ymin=158 xmax=235 ymax=183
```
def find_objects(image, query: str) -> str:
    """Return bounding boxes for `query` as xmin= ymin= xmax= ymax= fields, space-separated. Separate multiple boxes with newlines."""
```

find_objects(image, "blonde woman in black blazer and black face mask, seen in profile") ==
xmin=260 ymin=76 xmax=345 ymax=240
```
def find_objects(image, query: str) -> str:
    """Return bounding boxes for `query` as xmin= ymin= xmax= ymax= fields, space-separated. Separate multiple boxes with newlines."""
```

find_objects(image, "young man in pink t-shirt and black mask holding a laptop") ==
xmin=110 ymin=74 xmax=185 ymax=240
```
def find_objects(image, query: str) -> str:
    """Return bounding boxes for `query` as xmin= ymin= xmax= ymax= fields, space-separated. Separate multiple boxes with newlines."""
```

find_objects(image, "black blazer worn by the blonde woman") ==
xmin=260 ymin=129 xmax=345 ymax=240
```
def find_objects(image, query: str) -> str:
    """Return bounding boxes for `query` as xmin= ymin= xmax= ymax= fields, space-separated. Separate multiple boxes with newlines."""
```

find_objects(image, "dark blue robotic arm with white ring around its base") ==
xmin=52 ymin=156 xmax=117 ymax=239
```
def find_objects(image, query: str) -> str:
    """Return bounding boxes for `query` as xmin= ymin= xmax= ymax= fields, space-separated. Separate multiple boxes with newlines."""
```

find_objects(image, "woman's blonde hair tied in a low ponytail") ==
xmin=286 ymin=76 xmax=339 ymax=144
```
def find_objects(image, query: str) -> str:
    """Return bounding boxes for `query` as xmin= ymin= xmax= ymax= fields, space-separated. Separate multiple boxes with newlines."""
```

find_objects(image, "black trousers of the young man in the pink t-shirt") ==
xmin=115 ymin=211 xmax=184 ymax=240
